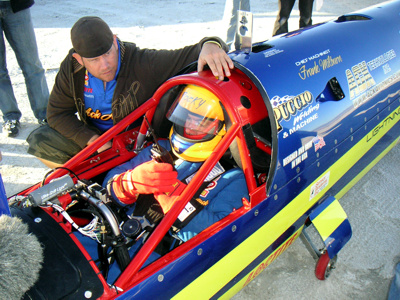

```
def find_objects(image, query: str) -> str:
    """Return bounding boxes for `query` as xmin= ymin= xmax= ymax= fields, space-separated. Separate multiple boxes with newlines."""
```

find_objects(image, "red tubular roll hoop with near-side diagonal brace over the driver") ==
xmin=115 ymin=75 xmax=256 ymax=290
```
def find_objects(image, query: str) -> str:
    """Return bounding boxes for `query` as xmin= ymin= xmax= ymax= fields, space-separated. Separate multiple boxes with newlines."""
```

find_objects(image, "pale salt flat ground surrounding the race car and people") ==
xmin=0 ymin=0 xmax=400 ymax=300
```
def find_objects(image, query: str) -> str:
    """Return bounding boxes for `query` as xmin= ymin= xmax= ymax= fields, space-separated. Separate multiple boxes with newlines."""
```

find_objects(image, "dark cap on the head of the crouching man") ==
xmin=71 ymin=16 xmax=114 ymax=58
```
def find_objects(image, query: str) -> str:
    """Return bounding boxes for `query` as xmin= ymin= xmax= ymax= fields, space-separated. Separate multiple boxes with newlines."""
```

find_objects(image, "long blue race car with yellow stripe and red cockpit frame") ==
xmin=0 ymin=1 xmax=400 ymax=299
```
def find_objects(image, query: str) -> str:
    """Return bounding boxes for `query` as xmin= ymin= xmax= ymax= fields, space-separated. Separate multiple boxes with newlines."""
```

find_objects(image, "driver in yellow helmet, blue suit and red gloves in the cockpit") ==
xmin=105 ymin=85 xmax=249 ymax=241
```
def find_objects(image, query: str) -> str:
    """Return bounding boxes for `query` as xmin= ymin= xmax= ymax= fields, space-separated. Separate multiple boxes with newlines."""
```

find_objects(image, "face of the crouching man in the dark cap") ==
xmin=78 ymin=36 xmax=118 ymax=82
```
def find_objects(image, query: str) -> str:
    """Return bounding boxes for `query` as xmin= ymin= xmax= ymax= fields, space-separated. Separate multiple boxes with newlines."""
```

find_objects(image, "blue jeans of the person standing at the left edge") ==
xmin=0 ymin=1 xmax=49 ymax=121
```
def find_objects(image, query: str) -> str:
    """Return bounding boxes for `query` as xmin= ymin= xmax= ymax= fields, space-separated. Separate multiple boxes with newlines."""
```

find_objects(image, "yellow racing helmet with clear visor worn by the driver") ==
xmin=167 ymin=85 xmax=226 ymax=162
